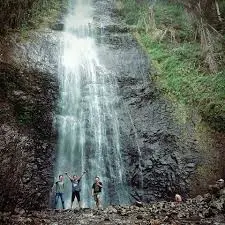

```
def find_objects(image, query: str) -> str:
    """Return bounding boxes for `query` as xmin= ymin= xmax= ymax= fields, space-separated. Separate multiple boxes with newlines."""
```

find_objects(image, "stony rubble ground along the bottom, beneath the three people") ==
xmin=0 ymin=189 xmax=225 ymax=225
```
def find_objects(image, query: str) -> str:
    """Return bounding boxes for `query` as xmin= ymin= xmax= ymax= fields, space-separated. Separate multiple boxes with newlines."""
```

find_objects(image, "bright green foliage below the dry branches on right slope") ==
xmin=140 ymin=33 xmax=225 ymax=129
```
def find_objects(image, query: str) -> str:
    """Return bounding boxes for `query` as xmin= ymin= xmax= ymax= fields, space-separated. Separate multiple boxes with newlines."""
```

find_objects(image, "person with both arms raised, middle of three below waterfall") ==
xmin=65 ymin=171 xmax=86 ymax=209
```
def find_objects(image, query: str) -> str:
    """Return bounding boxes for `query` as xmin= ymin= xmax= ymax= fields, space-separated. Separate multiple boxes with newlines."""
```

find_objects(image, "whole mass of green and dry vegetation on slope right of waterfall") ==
xmin=117 ymin=0 xmax=225 ymax=130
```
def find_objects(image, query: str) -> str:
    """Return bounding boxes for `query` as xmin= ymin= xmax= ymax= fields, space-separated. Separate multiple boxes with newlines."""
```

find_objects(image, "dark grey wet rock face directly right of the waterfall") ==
xmin=93 ymin=0 xmax=199 ymax=202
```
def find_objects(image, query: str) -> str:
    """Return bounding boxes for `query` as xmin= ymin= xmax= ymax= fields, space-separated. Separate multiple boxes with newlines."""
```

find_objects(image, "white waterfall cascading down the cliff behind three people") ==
xmin=55 ymin=0 xmax=128 ymax=207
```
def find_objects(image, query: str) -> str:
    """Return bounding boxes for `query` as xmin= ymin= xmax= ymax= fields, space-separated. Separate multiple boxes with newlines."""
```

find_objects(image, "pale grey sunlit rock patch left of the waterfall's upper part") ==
xmin=0 ymin=28 xmax=62 ymax=75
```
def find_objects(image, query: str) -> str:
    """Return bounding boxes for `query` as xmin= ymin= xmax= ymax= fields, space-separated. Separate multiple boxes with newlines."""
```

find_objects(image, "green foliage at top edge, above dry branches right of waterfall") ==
xmin=119 ymin=0 xmax=194 ymax=40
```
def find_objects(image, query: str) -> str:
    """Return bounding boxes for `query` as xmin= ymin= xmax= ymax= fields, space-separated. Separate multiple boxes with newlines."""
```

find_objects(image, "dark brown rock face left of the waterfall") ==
xmin=0 ymin=29 xmax=58 ymax=211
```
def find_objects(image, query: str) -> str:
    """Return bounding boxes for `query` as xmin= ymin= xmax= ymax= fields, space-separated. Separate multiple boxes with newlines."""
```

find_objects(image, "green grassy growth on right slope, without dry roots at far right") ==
xmin=117 ymin=0 xmax=225 ymax=130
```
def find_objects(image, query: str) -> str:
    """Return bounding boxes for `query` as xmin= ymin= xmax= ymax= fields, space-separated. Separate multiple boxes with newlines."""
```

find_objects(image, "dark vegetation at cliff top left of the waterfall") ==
xmin=0 ymin=0 xmax=65 ymax=34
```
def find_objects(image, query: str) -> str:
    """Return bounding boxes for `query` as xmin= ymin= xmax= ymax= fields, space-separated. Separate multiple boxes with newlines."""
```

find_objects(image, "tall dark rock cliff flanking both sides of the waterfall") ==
xmin=0 ymin=0 xmax=224 ymax=210
